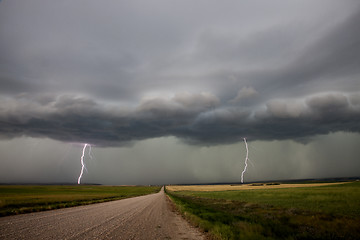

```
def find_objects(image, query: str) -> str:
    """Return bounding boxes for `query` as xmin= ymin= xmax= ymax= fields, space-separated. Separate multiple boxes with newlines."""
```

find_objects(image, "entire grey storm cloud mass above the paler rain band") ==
xmin=0 ymin=0 xmax=360 ymax=146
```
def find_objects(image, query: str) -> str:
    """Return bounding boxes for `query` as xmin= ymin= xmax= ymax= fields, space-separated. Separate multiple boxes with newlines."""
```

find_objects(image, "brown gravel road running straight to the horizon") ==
xmin=0 ymin=189 xmax=203 ymax=240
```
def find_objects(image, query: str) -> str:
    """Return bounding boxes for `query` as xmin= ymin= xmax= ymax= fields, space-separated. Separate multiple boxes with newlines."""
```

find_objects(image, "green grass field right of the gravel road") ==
xmin=167 ymin=182 xmax=360 ymax=239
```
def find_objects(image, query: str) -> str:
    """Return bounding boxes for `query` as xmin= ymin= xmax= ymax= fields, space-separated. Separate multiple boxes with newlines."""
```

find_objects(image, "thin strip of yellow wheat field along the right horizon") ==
xmin=166 ymin=182 xmax=346 ymax=192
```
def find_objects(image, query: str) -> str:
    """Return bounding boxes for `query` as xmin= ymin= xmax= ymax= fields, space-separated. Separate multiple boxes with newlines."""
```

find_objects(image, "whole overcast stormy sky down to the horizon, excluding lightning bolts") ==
xmin=0 ymin=0 xmax=360 ymax=184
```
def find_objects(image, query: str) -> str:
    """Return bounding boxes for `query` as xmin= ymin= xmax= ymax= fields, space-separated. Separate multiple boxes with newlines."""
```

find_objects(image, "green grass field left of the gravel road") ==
xmin=0 ymin=185 xmax=160 ymax=216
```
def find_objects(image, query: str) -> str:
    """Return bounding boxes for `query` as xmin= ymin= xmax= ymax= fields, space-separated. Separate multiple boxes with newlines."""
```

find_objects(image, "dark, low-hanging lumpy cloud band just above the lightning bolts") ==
xmin=0 ymin=92 xmax=360 ymax=146
